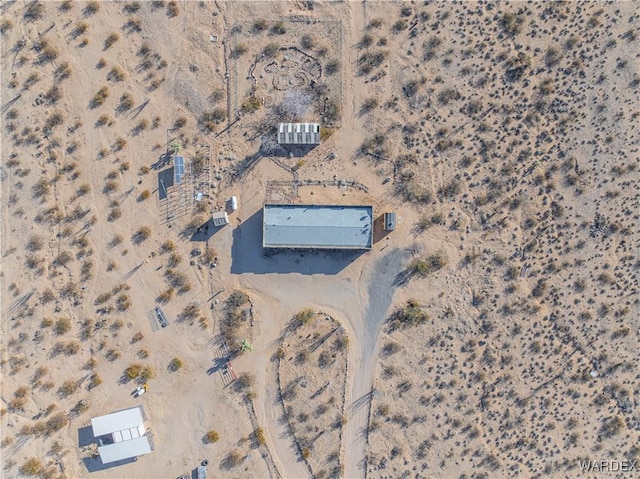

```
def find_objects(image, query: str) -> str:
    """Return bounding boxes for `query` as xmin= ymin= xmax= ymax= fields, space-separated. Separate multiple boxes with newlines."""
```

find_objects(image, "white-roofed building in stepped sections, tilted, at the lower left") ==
xmin=91 ymin=406 xmax=151 ymax=464
